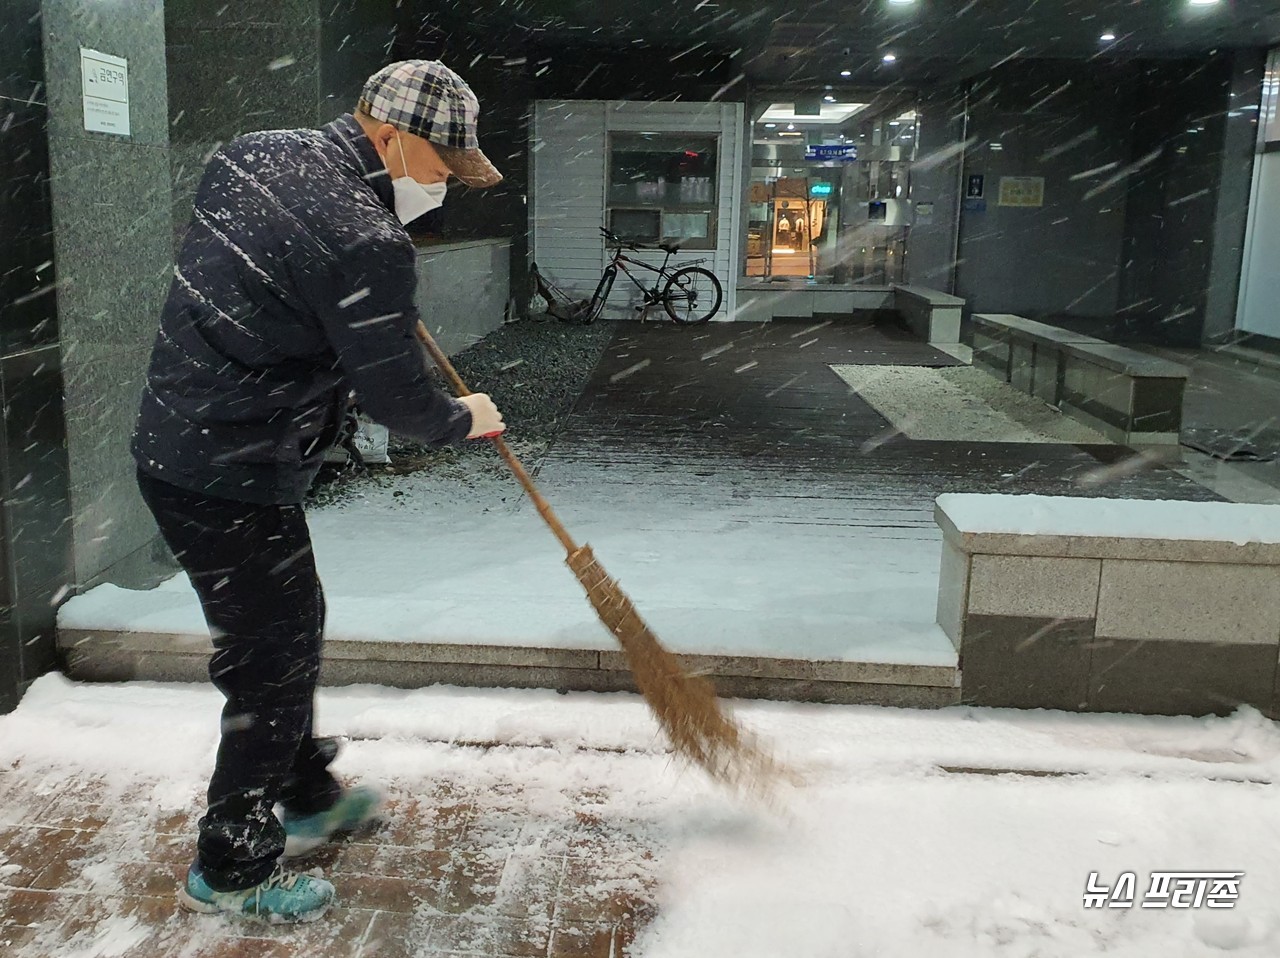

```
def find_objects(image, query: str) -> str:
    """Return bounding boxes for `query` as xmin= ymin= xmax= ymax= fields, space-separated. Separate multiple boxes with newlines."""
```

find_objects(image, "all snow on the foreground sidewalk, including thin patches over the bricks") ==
xmin=0 ymin=676 xmax=1280 ymax=958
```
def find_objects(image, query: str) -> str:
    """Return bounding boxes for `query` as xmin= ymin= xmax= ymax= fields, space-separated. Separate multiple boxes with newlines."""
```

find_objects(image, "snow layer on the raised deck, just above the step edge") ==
xmin=59 ymin=457 xmax=955 ymax=666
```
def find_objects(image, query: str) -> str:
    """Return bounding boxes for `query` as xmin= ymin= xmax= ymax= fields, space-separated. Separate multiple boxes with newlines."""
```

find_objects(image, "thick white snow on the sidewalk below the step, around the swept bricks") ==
xmin=0 ymin=676 xmax=1280 ymax=958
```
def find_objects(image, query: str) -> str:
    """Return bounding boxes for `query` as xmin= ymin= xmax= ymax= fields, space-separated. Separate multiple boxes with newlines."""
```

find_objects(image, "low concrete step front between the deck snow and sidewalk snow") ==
xmin=58 ymin=629 xmax=960 ymax=708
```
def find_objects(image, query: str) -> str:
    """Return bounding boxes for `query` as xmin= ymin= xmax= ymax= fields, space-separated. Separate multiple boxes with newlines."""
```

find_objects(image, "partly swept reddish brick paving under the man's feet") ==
xmin=0 ymin=768 xmax=657 ymax=958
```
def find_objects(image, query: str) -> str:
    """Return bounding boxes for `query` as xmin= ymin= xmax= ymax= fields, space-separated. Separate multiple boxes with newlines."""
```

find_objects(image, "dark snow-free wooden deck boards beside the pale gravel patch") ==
xmin=560 ymin=321 xmax=1216 ymax=502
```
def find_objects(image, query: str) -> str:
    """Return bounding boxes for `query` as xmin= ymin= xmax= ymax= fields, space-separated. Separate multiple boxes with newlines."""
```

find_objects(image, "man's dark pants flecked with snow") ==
xmin=138 ymin=473 xmax=340 ymax=891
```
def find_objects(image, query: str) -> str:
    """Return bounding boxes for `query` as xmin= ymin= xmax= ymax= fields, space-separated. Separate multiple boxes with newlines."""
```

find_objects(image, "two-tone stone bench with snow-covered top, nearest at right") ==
xmin=936 ymin=494 xmax=1280 ymax=715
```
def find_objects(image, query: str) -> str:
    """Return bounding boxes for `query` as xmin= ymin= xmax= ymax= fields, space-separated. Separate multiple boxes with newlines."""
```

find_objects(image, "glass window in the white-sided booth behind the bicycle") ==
xmin=608 ymin=133 xmax=718 ymax=250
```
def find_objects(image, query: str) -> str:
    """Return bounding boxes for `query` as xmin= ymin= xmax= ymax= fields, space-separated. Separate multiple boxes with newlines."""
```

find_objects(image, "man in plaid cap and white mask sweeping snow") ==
xmin=133 ymin=60 xmax=504 ymax=921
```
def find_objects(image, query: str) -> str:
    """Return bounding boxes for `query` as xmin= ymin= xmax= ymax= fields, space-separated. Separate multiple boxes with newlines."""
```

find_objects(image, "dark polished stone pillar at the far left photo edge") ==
xmin=0 ymin=0 xmax=72 ymax=712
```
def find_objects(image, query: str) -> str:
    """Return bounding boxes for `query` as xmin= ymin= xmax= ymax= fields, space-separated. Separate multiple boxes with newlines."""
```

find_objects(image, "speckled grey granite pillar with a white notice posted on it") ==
xmin=44 ymin=0 xmax=173 ymax=599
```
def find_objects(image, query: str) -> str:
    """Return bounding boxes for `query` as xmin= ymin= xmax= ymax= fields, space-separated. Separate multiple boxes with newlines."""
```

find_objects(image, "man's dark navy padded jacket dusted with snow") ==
xmin=133 ymin=114 xmax=471 ymax=503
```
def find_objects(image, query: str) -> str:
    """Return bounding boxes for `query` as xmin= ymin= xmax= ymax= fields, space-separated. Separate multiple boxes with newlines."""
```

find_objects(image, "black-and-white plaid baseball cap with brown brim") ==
xmin=360 ymin=60 xmax=502 ymax=186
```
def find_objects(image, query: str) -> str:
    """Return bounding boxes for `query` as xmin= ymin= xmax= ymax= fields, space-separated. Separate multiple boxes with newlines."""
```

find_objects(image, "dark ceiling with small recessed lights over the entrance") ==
xmin=424 ymin=0 xmax=1280 ymax=83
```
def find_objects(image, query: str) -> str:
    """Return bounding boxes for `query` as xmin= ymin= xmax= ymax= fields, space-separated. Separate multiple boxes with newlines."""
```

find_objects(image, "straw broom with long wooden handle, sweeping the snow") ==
xmin=417 ymin=320 xmax=781 ymax=792
